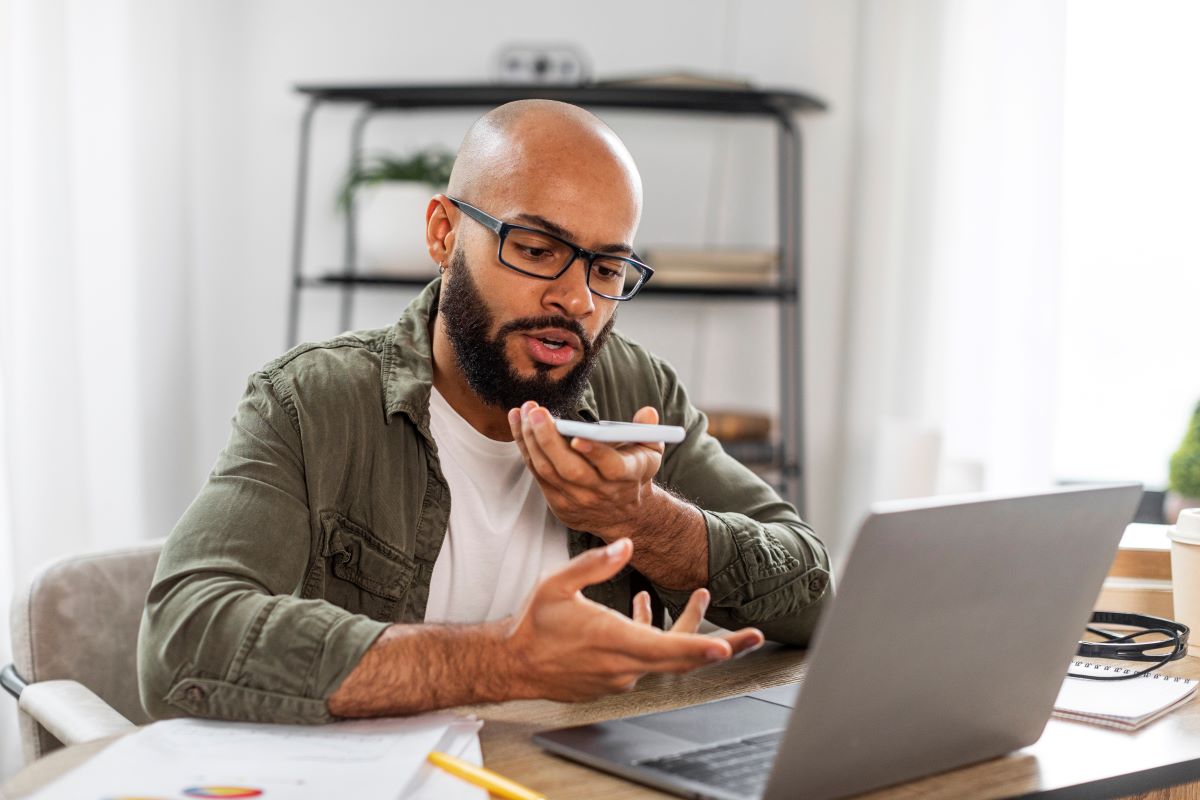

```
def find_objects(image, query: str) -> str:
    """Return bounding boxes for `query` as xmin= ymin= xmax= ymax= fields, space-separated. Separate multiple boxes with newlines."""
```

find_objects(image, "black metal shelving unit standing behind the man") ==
xmin=287 ymin=84 xmax=826 ymax=513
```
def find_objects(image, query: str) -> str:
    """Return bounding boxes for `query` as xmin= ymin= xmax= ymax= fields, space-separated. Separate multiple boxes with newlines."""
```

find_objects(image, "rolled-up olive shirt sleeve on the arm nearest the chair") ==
xmin=138 ymin=373 xmax=386 ymax=723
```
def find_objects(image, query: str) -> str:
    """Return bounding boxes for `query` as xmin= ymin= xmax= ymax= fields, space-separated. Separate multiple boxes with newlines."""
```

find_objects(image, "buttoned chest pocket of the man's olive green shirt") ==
xmin=310 ymin=511 xmax=415 ymax=622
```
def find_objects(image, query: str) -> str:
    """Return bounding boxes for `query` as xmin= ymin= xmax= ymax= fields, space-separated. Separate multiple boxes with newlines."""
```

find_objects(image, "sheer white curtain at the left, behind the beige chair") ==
xmin=0 ymin=0 xmax=191 ymax=775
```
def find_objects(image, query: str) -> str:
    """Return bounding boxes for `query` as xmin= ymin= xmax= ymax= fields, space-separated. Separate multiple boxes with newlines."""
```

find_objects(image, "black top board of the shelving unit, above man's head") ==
xmin=295 ymin=83 xmax=828 ymax=115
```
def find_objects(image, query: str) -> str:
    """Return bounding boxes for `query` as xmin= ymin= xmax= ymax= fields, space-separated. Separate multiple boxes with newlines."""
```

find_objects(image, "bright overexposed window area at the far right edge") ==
xmin=1055 ymin=0 xmax=1200 ymax=488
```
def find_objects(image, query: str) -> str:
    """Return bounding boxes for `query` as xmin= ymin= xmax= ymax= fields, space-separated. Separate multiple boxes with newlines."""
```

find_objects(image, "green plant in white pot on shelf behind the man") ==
xmin=338 ymin=149 xmax=454 ymax=275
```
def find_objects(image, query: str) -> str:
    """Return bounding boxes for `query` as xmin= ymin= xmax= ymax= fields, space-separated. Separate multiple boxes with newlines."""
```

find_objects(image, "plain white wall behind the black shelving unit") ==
xmin=176 ymin=0 xmax=857 ymax=544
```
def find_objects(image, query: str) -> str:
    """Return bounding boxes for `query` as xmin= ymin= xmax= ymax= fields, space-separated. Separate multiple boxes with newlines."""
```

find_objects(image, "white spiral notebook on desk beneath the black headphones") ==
xmin=1054 ymin=661 xmax=1200 ymax=730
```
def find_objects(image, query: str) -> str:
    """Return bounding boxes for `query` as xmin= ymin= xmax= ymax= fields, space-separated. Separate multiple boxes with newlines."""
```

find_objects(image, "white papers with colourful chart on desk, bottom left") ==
xmin=31 ymin=714 xmax=480 ymax=800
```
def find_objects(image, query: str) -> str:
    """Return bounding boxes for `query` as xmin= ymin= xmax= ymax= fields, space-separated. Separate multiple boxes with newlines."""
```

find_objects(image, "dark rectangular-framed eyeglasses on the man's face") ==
xmin=446 ymin=196 xmax=654 ymax=300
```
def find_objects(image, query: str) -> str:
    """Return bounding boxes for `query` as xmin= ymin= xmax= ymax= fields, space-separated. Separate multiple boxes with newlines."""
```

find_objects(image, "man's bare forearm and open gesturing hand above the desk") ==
xmin=328 ymin=540 xmax=763 ymax=717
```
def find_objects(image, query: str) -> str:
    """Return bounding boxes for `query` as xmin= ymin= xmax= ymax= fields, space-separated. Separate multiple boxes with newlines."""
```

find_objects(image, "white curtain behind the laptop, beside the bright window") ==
xmin=834 ymin=0 xmax=1066 ymax=557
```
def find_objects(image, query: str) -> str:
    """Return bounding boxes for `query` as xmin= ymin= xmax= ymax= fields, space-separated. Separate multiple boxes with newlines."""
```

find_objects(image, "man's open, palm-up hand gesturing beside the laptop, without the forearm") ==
xmin=504 ymin=539 xmax=763 ymax=700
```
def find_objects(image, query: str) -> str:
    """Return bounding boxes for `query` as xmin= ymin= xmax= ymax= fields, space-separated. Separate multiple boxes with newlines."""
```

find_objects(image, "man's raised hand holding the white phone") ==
xmin=509 ymin=401 xmax=662 ymax=541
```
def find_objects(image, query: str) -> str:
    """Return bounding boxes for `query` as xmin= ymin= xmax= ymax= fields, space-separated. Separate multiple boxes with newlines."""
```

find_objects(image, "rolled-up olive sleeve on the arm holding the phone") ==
xmin=655 ymin=362 xmax=833 ymax=645
